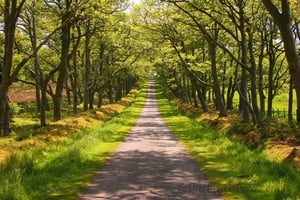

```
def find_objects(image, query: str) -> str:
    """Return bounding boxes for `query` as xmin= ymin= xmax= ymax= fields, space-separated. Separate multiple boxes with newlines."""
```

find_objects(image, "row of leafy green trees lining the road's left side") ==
xmin=0 ymin=0 xmax=146 ymax=135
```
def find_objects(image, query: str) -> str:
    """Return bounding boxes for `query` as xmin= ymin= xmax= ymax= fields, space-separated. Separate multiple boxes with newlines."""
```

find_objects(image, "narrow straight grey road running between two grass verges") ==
xmin=79 ymin=81 xmax=222 ymax=200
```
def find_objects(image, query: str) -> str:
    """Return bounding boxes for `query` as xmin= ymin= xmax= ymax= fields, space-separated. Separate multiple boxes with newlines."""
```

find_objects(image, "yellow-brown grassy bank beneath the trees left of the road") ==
xmin=0 ymin=89 xmax=144 ymax=162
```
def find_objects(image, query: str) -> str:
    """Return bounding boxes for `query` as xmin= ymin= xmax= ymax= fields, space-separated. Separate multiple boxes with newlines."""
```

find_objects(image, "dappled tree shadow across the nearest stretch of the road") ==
xmin=81 ymin=150 xmax=219 ymax=199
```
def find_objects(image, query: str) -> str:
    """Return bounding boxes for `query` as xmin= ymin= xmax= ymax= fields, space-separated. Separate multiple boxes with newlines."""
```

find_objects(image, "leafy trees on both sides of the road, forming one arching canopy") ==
xmin=0 ymin=0 xmax=300 ymax=135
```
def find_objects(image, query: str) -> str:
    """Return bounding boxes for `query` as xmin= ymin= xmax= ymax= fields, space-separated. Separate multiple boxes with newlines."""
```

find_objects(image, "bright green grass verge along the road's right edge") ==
xmin=157 ymin=82 xmax=300 ymax=200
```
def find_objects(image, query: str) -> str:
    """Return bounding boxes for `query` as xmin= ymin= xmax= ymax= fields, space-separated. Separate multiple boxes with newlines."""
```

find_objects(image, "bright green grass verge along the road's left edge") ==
xmin=0 ymin=86 xmax=147 ymax=200
